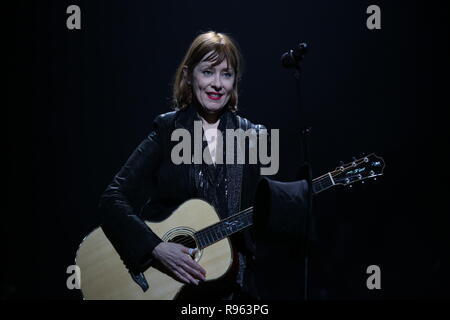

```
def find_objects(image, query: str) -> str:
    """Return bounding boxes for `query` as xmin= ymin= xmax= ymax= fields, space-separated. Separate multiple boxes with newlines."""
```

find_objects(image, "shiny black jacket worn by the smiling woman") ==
xmin=99 ymin=106 xmax=264 ymax=298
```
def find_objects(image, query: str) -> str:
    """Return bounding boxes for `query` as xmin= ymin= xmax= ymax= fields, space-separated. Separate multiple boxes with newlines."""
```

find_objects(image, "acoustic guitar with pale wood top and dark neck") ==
xmin=75 ymin=154 xmax=384 ymax=300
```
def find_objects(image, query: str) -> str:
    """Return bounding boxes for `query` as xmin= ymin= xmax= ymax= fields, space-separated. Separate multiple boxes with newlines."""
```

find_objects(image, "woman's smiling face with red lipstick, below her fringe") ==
xmin=192 ymin=54 xmax=235 ymax=119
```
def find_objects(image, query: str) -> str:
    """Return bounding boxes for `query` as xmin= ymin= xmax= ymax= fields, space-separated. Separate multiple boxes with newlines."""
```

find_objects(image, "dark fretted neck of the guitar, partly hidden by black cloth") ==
xmin=195 ymin=173 xmax=335 ymax=249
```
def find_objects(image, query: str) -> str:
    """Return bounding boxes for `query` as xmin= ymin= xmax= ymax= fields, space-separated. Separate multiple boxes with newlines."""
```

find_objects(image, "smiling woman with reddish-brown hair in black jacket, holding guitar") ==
xmin=100 ymin=31 xmax=268 ymax=299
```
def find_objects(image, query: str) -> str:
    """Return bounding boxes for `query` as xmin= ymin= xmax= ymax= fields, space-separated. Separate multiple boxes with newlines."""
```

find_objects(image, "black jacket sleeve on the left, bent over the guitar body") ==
xmin=99 ymin=117 xmax=162 ymax=273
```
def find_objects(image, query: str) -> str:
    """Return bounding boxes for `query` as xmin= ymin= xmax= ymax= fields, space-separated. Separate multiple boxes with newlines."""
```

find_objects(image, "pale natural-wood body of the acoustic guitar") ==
xmin=76 ymin=199 xmax=233 ymax=300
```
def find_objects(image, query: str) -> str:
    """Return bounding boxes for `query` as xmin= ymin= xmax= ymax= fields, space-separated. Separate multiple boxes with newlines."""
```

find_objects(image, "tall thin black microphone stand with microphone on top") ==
xmin=282 ymin=43 xmax=313 ymax=300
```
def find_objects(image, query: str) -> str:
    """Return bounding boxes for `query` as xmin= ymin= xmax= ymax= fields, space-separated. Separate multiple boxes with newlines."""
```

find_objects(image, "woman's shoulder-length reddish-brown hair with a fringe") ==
xmin=173 ymin=31 xmax=242 ymax=112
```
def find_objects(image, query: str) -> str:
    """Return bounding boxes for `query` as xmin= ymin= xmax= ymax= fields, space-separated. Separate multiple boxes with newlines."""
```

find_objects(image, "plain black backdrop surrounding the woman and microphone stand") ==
xmin=1 ymin=0 xmax=448 ymax=300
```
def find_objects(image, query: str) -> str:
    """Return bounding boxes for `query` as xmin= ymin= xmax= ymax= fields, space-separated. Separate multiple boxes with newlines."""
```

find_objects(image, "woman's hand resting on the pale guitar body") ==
xmin=153 ymin=242 xmax=206 ymax=285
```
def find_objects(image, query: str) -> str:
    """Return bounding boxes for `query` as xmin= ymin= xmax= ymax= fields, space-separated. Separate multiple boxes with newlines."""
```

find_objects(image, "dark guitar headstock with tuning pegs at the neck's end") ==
xmin=330 ymin=153 xmax=385 ymax=186
